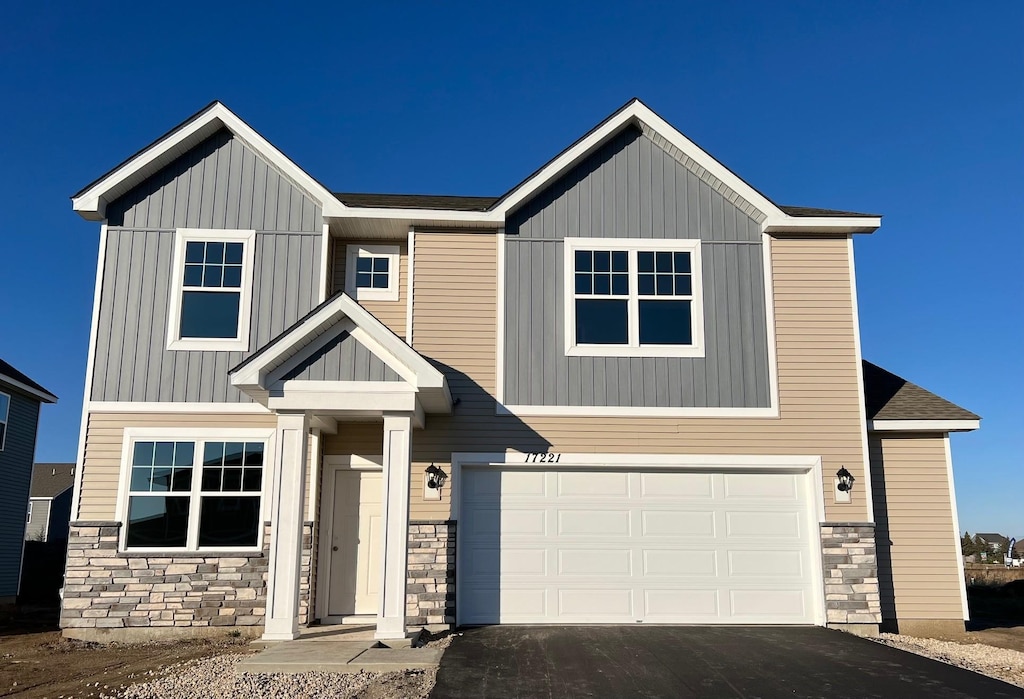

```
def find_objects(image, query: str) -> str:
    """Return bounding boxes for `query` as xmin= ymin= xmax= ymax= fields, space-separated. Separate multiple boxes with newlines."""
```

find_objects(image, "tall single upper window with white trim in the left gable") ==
xmin=167 ymin=229 xmax=256 ymax=351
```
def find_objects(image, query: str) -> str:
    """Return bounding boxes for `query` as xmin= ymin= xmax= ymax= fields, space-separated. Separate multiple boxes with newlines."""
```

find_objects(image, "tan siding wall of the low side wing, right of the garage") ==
xmin=868 ymin=434 xmax=964 ymax=620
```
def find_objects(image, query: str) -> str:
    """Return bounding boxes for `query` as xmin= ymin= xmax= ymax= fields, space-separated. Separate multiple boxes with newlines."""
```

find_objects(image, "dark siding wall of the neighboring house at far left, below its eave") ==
xmin=0 ymin=388 xmax=39 ymax=600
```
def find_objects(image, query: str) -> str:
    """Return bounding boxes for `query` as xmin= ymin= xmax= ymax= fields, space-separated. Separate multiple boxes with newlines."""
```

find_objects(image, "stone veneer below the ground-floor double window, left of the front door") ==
xmin=60 ymin=521 xmax=312 ymax=640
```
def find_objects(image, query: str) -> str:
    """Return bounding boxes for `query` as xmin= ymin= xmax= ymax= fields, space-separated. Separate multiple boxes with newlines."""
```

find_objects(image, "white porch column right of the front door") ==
xmin=374 ymin=414 xmax=413 ymax=639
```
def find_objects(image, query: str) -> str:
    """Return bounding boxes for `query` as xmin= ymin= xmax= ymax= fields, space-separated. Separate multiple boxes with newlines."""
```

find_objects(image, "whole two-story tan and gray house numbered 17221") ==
xmin=60 ymin=100 xmax=979 ymax=640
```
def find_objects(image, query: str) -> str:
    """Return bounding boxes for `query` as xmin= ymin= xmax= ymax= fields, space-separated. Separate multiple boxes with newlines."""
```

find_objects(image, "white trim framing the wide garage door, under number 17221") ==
xmin=450 ymin=451 xmax=826 ymax=626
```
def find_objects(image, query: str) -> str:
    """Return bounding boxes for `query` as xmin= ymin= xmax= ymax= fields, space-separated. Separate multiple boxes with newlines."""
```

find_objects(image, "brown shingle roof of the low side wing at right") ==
xmin=864 ymin=360 xmax=981 ymax=427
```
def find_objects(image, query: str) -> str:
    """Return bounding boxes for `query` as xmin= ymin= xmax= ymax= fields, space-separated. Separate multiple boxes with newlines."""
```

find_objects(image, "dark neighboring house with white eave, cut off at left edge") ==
xmin=0 ymin=359 xmax=57 ymax=604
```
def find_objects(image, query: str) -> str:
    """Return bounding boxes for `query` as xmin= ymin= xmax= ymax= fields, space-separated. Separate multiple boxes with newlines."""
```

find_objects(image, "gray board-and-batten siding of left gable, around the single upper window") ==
xmin=90 ymin=130 xmax=323 ymax=402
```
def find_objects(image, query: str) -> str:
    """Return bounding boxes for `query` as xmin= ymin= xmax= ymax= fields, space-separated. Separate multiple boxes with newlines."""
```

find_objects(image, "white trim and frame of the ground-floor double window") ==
xmin=117 ymin=427 xmax=276 ymax=555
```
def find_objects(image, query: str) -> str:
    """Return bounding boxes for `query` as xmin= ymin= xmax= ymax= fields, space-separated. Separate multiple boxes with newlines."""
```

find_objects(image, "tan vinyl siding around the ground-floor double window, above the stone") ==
xmin=72 ymin=412 xmax=313 ymax=521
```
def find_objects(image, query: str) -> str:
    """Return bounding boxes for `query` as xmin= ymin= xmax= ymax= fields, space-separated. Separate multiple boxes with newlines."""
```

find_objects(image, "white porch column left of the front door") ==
xmin=263 ymin=412 xmax=309 ymax=641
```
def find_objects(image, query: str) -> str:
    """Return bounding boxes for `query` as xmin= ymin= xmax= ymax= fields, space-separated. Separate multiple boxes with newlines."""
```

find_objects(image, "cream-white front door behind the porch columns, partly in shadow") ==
xmin=328 ymin=469 xmax=383 ymax=617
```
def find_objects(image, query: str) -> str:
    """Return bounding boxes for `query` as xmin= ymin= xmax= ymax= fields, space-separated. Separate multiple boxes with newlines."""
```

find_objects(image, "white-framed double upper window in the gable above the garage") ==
xmin=565 ymin=238 xmax=703 ymax=357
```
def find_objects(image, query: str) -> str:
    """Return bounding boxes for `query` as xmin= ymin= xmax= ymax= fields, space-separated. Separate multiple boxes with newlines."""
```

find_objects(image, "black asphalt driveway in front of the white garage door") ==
xmin=430 ymin=626 xmax=1024 ymax=699
